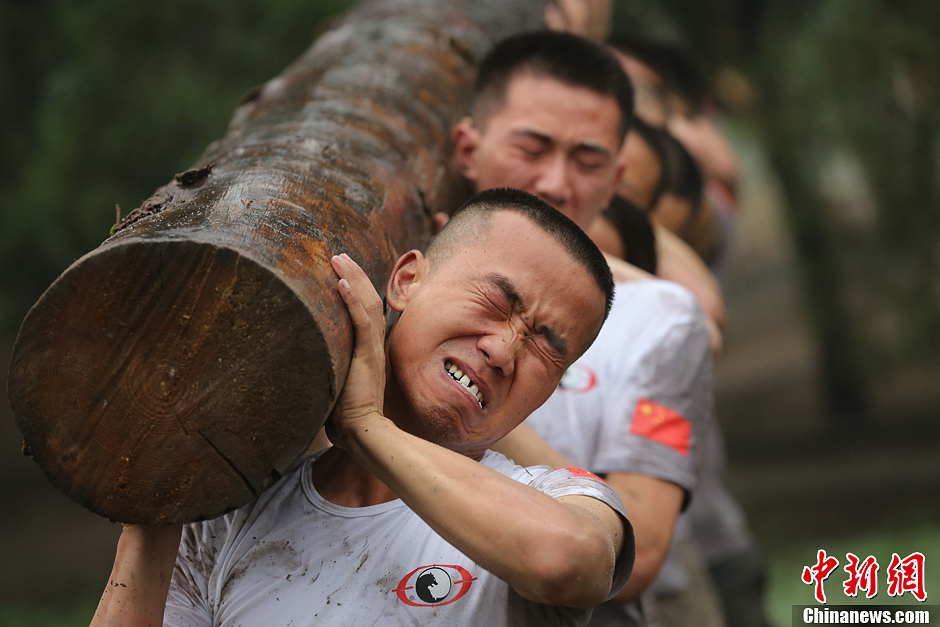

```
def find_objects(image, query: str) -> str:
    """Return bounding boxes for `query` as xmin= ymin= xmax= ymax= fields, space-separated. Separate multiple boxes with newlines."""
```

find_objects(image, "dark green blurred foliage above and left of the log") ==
xmin=0 ymin=0 xmax=350 ymax=332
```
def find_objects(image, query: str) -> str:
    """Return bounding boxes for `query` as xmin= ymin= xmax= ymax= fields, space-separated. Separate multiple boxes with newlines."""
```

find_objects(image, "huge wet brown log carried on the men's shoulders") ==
xmin=9 ymin=0 xmax=543 ymax=524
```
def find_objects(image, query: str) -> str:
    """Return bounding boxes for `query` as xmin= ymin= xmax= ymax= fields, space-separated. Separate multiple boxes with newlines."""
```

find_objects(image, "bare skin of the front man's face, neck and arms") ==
xmin=92 ymin=212 xmax=625 ymax=626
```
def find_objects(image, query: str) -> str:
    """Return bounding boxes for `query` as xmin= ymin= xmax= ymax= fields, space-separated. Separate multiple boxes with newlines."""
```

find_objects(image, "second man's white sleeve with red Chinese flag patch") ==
xmin=592 ymin=294 xmax=713 ymax=507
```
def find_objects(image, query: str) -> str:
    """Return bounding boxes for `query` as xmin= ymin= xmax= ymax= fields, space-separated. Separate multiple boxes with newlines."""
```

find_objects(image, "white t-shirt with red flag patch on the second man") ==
xmin=527 ymin=279 xmax=714 ymax=625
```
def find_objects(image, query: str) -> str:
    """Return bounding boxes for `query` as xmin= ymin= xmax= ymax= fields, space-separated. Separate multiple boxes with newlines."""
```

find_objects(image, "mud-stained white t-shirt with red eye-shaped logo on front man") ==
xmin=164 ymin=451 xmax=633 ymax=627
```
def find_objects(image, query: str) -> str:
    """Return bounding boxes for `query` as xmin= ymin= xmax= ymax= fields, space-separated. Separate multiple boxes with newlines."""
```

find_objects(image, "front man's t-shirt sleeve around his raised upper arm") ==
xmin=529 ymin=466 xmax=636 ymax=599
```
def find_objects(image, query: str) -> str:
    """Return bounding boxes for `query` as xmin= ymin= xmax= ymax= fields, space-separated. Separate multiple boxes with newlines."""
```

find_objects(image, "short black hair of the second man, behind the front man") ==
xmin=472 ymin=30 xmax=634 ymax=141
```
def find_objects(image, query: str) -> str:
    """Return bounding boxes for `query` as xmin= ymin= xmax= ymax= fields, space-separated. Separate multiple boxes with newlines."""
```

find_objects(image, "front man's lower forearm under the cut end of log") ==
xmin=91 ymin=525 xmax=182 ymax=627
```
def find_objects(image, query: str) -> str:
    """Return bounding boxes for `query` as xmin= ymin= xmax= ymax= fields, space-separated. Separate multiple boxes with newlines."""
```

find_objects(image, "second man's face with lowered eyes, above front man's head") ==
xmin=454 ymin=72 xmax=623 ymax=229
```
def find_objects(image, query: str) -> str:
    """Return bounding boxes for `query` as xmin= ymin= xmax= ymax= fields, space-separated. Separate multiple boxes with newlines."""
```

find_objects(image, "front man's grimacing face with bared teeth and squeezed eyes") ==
xmin=386 ymin=211 xmax=604 ymax=457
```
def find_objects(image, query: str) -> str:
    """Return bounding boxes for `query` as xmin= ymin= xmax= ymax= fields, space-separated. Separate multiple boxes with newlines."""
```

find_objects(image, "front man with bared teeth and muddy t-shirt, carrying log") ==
xmin=92 ymin=190 xmax=633 ymax=626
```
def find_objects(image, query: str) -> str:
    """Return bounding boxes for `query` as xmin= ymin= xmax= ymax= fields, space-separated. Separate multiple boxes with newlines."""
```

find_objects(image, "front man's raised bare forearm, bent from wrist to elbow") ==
xmin=346 ymin=417 xmax=620 ymax=606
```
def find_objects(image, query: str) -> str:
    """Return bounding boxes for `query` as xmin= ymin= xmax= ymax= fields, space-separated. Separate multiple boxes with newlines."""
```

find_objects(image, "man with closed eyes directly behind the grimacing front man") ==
xmin=454 ymin=32 xmax=712 ymax=624
